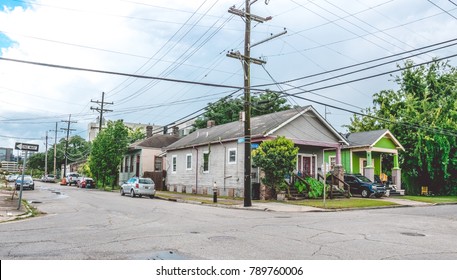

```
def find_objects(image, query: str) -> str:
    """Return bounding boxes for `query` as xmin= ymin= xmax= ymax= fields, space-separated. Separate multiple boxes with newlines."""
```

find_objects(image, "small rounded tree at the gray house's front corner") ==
xmin=252 ymin=136 xmax=298 ymax=198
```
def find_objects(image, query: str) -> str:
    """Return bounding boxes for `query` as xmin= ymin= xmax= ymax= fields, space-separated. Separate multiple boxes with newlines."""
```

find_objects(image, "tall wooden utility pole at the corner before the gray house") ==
xmin=227 ymin=0 xmax=285 ymax=207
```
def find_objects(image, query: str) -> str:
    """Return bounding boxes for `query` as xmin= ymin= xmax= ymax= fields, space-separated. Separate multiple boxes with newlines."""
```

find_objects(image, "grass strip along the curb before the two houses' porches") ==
xmin=288 ymin=198 xmax=398 ymax=209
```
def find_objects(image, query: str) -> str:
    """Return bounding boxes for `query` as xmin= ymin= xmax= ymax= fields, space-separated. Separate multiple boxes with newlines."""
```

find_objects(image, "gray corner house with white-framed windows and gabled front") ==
xmin=165 ymin=106 xmax=348 ymax=197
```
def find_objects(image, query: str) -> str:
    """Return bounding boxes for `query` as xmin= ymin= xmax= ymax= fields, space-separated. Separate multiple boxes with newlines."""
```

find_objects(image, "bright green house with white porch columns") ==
xmin=325 ymin=129 xmax=405 ymax=194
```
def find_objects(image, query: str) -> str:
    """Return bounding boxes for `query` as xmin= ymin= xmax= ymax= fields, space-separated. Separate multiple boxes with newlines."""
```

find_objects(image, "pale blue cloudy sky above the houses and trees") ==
xmin=0 ymin=0 xmax=457 ymax=152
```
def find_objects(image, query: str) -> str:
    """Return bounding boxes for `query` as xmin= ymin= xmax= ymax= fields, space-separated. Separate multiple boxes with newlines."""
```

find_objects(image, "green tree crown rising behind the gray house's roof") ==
xmin=194 ymin=91 xmax=291 ymax=128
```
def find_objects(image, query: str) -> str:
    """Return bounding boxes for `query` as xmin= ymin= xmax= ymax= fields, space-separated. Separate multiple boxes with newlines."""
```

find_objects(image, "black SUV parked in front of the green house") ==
xmin=344 ymin=174 xmax=386 ymax=198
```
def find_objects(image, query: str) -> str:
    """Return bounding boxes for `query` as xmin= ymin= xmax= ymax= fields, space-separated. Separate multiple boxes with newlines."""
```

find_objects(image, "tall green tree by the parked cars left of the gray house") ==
xmin=89 ymin=120 xmax=129 ymax=189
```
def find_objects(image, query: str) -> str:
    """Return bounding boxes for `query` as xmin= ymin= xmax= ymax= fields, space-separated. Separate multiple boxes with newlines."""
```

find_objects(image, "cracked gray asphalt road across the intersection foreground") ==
xmin=0 ymin=182 xmax=457 ymax=260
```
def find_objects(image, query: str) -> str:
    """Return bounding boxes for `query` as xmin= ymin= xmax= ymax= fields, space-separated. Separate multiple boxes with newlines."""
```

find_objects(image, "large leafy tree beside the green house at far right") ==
xmin=347 ymin=61 xmax=457 ymax=194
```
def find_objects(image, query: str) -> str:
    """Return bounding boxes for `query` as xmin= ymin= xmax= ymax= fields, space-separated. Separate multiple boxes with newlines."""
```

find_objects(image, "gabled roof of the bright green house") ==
xmin=346 ymin=129 xmax=405 ymax=150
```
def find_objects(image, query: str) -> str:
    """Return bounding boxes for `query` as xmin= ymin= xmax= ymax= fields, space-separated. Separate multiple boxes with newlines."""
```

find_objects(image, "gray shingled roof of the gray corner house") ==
xmin=166 ymin=106 xmax=346 ymax=150
